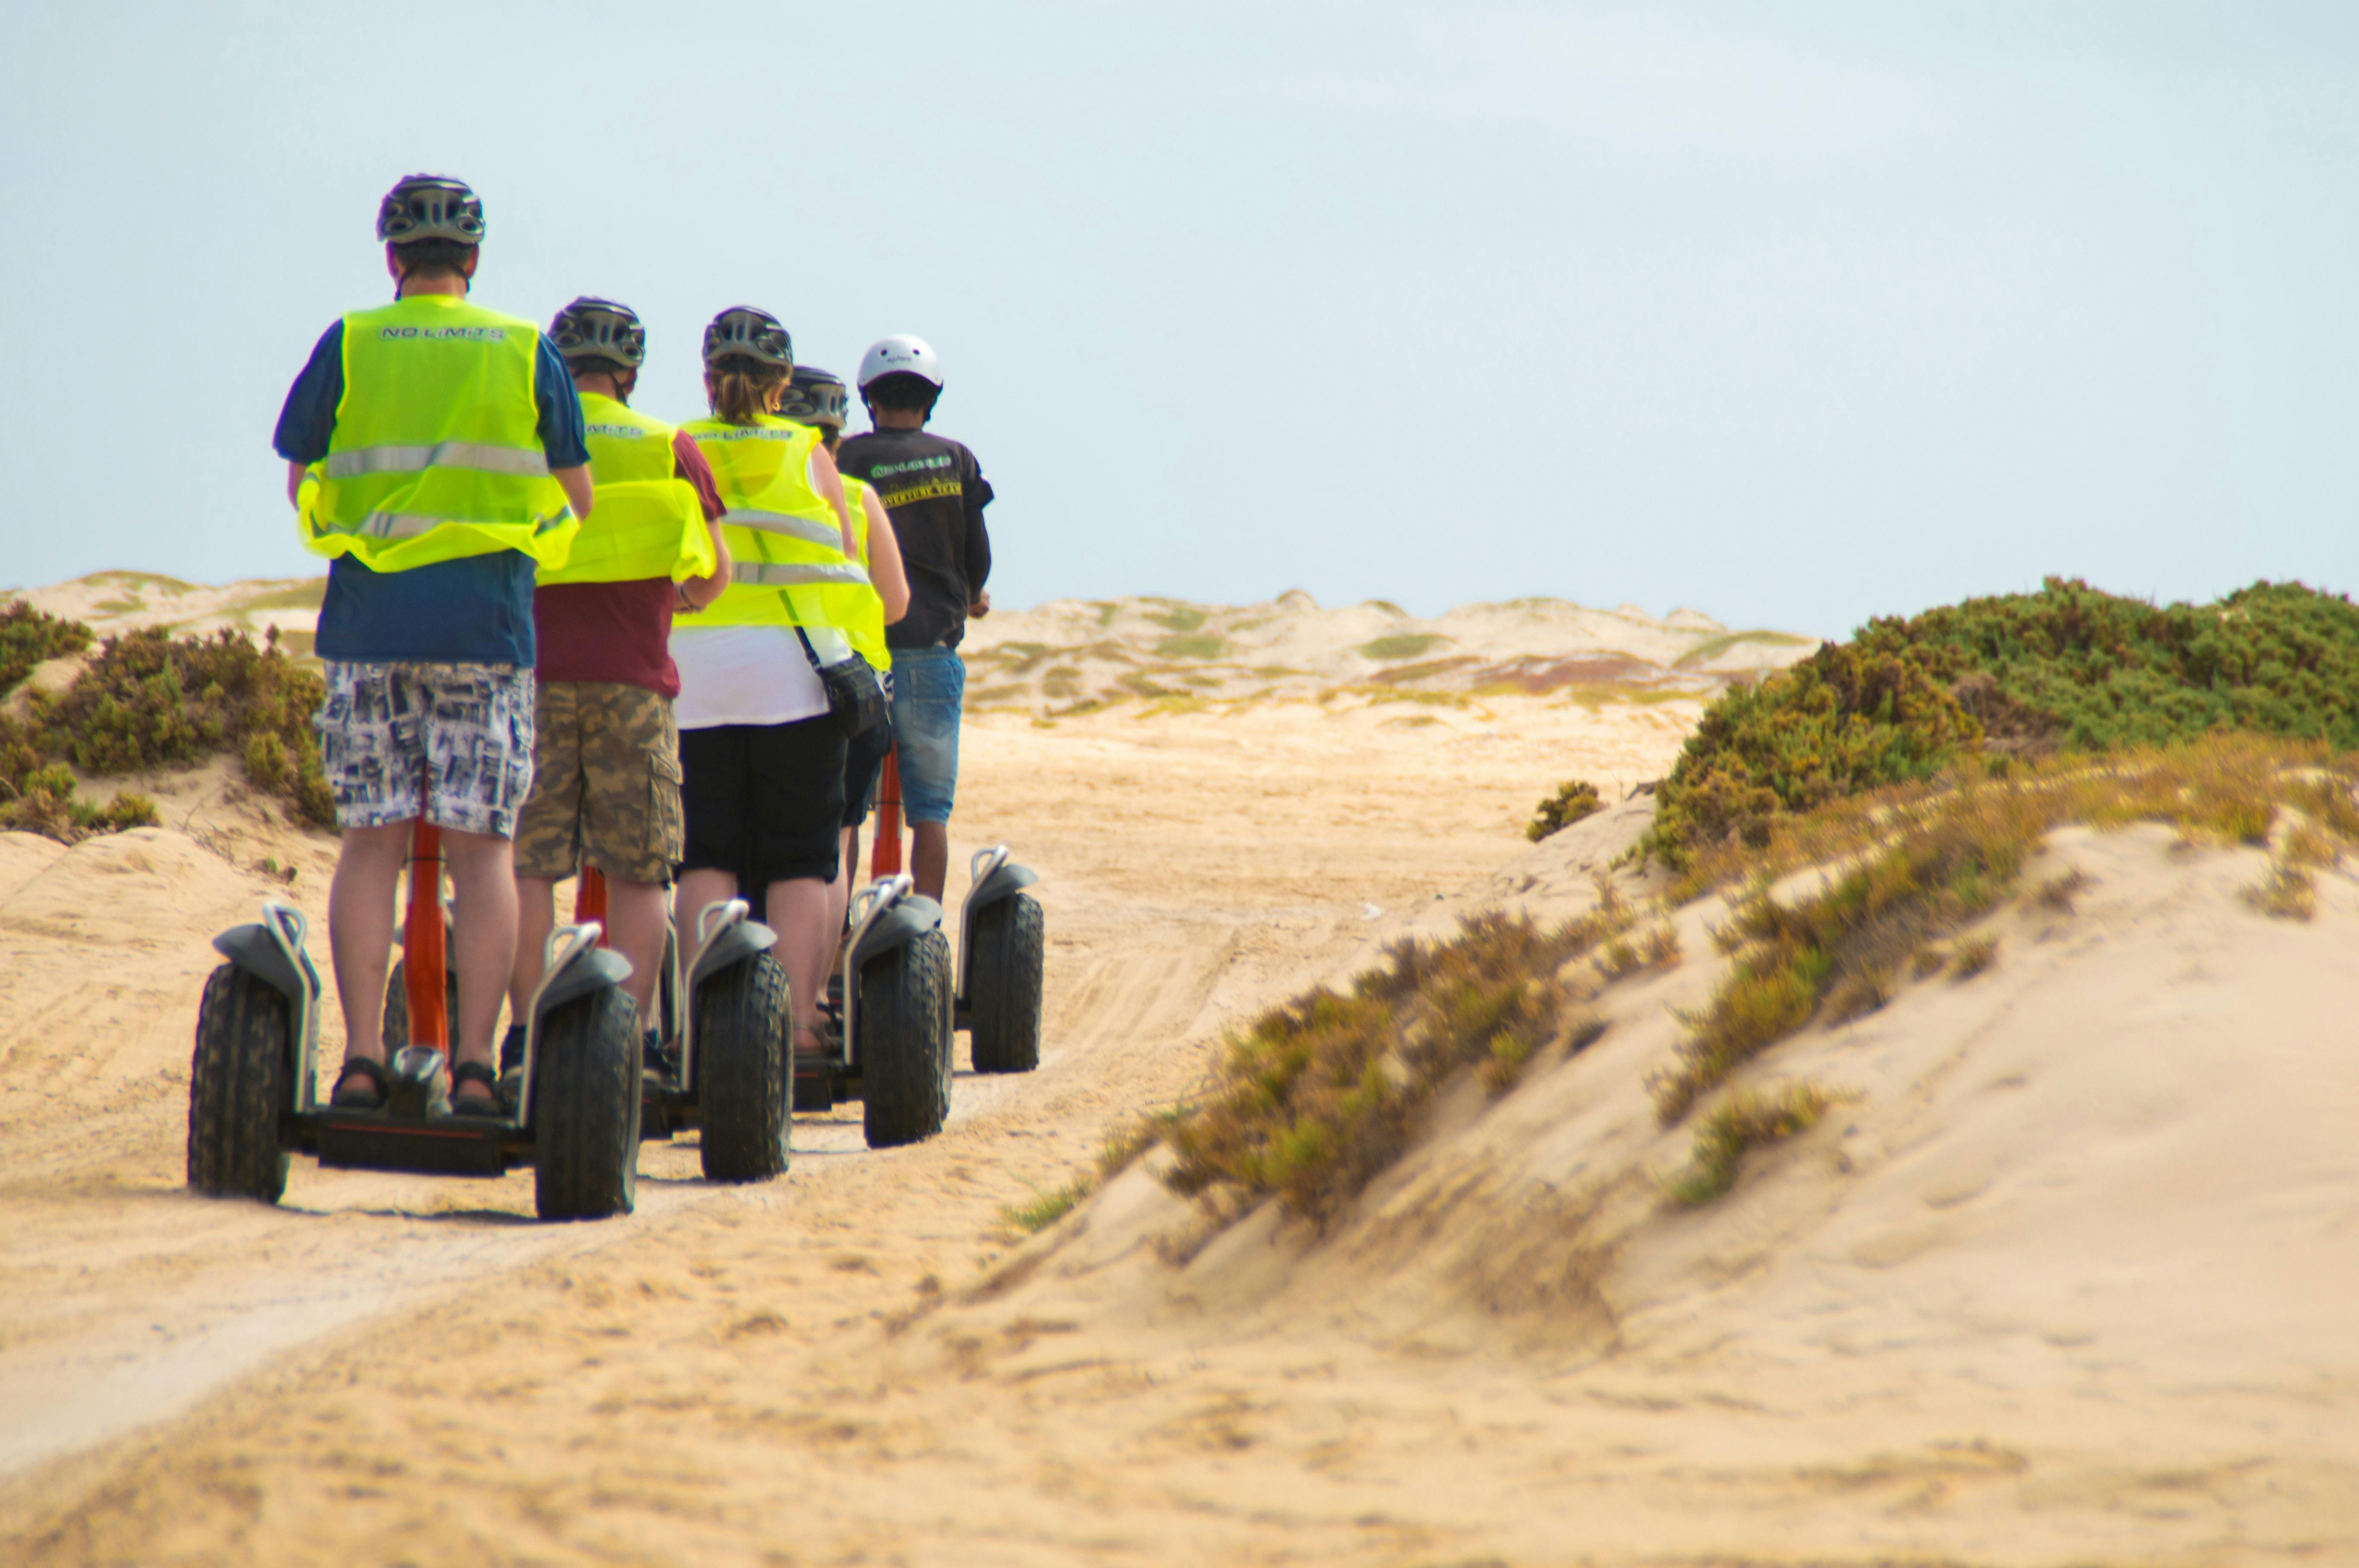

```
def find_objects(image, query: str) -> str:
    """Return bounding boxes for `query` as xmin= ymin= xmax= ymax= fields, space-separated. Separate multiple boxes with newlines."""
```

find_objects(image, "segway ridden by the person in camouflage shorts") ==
xmin=604 ymin=870 xmax=793 ymax=1181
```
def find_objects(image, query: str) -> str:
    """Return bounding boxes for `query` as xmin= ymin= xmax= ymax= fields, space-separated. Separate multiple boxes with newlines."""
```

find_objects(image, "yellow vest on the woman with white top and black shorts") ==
xmin=672 ymin=415 xmax=868 ymax=665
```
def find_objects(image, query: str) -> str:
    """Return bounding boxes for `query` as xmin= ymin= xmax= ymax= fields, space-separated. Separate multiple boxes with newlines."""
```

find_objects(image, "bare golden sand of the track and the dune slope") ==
xmin=0 ymin=580 xmax=2359 ymax=1563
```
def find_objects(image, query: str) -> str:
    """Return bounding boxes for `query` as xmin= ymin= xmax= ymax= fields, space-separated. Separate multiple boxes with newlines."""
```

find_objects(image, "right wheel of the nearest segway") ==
xmin=533 ymin=986 xmax=639 ymax=1219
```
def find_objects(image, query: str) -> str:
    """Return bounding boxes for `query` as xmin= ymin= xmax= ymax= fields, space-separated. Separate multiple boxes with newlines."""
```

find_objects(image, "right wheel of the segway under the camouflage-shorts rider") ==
xmin=696 ymin=952 xmax=795 ymax=1181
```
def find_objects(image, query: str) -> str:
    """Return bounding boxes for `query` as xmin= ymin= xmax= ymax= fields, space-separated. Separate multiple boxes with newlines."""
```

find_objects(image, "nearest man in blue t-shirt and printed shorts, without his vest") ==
xmin=274 ymin=174 xmax=590 ymax=1115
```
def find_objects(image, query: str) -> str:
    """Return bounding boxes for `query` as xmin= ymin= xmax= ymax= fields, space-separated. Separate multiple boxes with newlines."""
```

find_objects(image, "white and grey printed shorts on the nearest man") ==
xmin=314 ymin=660 xmax=533 ymax=839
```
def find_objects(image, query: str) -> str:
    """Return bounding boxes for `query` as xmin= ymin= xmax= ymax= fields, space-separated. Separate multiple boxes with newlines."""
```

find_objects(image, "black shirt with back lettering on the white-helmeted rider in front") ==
xmin=835 ymin=429 xmax=991 ymax=648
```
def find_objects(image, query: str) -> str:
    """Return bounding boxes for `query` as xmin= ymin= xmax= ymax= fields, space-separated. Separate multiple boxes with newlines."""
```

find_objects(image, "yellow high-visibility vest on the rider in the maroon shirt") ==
xmin=540 ymin=391 xmax=712 ymax=585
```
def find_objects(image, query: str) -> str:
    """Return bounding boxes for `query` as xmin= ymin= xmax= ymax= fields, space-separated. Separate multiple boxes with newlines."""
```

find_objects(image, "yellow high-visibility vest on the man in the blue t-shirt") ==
xmin=297 ymin=295 xmax=580 ymax=571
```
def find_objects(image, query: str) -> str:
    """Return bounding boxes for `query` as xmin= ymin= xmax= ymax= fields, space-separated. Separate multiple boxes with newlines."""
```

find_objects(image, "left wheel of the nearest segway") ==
xmin=189 ymin=965 xmax=295 ymax=1203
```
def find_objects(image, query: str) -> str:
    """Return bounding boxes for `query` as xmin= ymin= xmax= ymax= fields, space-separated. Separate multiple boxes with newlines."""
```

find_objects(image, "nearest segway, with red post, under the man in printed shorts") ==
xmin=189 ymin=823 xmax=639 ymax=1219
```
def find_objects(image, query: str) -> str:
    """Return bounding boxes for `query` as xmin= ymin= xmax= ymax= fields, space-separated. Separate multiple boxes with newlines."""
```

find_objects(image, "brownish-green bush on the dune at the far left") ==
xmin=0 ymin=601 xmax=335 ymax=842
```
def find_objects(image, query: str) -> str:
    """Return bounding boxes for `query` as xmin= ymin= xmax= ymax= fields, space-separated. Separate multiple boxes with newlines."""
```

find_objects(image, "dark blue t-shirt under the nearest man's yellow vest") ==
xmin=271 ymin=321 xmax=590 ymax=667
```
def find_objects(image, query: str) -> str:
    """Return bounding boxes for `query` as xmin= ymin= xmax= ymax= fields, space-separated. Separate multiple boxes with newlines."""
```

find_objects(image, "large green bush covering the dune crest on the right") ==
xmin=1642 ymin=578 xmax=2359 ymax=870
